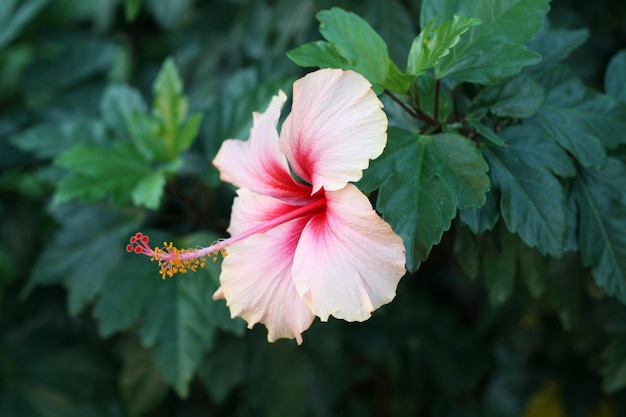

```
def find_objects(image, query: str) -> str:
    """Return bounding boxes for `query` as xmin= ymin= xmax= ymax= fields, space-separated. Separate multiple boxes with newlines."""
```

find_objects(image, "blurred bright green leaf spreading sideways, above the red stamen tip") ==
xmin=53 ymin=141 xmax=163 ymax=208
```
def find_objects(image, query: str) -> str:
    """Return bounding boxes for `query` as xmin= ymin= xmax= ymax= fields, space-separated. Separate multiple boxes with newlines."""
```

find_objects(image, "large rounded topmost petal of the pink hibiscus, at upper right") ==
xmin=280 ymin=69 xmax=387 ymax=193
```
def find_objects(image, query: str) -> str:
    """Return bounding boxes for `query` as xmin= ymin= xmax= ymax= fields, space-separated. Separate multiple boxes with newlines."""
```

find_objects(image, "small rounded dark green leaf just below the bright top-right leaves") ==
xmin=472 ymin=75 xmax=545 ymax=119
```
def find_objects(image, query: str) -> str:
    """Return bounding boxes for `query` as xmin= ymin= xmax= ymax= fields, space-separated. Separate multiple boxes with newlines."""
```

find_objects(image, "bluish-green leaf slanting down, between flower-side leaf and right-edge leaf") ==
xmin=483 ymin=147 xmax=566 ymax=256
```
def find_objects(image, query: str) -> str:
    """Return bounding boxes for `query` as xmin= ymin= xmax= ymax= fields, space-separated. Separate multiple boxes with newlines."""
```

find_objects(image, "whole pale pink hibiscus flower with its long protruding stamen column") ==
xmin=128 ymin=69 xmax=405 ymax=343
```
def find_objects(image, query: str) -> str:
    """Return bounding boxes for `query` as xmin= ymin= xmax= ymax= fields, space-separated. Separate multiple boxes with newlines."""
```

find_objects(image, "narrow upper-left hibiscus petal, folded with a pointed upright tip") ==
xmin=213 ymin=91 xmax=310 ymax=200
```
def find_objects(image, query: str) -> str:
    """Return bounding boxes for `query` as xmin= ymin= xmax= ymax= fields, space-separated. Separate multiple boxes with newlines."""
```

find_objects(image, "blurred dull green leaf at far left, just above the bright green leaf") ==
xmin=11 ymin=119 xmax=109 ymax=159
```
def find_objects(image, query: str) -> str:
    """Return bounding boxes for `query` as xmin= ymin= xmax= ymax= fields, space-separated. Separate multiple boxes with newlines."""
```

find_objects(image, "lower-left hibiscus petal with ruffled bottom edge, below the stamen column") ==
xmin=220 ymin=219 xmax=315 ymax=344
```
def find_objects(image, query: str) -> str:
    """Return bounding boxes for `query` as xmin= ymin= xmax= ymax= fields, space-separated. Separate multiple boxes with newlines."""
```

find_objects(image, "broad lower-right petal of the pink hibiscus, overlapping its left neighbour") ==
xmin=293 ymin=184 xmax=405 ymax=321
